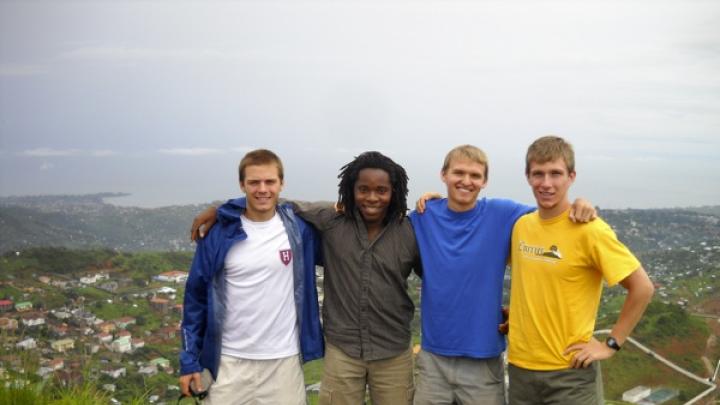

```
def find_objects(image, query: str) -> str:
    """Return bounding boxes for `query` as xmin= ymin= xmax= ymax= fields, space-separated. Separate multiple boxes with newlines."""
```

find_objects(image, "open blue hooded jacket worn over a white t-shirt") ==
xmin=180 ymin=198 xmax=325 ymax=379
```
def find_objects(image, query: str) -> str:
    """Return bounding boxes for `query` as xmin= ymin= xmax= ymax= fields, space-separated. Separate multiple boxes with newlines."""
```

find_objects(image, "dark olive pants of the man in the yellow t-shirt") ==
xmin=508 ymin=362 xmax=604 ymax=405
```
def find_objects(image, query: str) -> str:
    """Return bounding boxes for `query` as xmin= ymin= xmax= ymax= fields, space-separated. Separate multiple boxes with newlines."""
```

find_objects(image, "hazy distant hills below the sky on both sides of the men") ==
xmin=0 ymin=193 xmax=720 ymax=254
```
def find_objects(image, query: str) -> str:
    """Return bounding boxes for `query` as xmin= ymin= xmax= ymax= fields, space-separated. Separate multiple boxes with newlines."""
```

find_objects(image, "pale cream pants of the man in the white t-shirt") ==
xmin=203 ymin=356 xmax=307 ymax=405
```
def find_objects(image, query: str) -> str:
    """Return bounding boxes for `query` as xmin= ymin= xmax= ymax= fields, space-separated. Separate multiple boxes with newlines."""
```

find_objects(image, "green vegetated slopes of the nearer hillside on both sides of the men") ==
xmin=0 ymin=248 xmax=720 ymax=404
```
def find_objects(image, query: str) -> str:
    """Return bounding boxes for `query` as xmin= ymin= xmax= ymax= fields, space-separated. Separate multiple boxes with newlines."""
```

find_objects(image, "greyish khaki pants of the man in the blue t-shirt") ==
xmin=415 ymin=351 xmax=505 ymax=405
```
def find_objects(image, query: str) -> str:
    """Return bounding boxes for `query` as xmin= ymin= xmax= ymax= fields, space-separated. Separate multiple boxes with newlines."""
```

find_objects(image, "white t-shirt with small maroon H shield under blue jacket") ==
xmin=222 ymin=213 xmax=300 ymax=360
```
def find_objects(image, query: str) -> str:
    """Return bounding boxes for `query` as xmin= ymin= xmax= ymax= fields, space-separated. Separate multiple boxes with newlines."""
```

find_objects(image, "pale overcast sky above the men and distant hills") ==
xmin=0 ymin=0 xmax=720 ymax=208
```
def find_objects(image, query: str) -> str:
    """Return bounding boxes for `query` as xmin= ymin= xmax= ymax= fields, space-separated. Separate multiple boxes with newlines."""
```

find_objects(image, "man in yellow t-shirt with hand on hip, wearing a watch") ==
xmin=508 ymin=136 xmax=653 ymax=405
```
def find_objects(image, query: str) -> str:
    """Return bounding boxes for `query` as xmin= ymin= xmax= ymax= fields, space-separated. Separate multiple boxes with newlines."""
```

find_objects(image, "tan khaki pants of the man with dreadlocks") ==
xmin=319 ymin=343 xmax=413 ymax=405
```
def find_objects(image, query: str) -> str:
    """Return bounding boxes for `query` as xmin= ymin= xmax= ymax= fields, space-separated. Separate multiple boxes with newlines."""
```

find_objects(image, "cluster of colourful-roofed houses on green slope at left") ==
xmin=0 ymin=270 xmax=188 ymax=403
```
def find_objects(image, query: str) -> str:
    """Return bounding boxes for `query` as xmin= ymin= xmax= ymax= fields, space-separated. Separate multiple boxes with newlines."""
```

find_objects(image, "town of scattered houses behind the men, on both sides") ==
xmin=0 ymin=246 xmax=720 ymax=405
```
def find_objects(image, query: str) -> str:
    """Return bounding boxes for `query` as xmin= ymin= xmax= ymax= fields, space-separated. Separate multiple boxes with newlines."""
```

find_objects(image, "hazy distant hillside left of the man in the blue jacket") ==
xmin=0 ymin=193 xmax=212 ymax=254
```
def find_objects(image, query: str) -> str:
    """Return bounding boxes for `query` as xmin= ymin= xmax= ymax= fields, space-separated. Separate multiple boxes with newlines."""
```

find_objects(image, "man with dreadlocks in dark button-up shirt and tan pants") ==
xmin=192 ymin=152 xmax=421 ymax=405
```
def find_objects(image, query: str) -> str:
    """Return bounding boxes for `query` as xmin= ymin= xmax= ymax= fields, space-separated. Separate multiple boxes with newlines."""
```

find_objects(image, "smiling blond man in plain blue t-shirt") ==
xmin=410 ymin=145 xmax=595 ymax=405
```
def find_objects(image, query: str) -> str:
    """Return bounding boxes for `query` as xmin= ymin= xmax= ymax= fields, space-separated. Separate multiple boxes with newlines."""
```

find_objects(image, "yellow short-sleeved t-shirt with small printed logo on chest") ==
xmin=508 ymin=211 xmax=640 ymax=370
